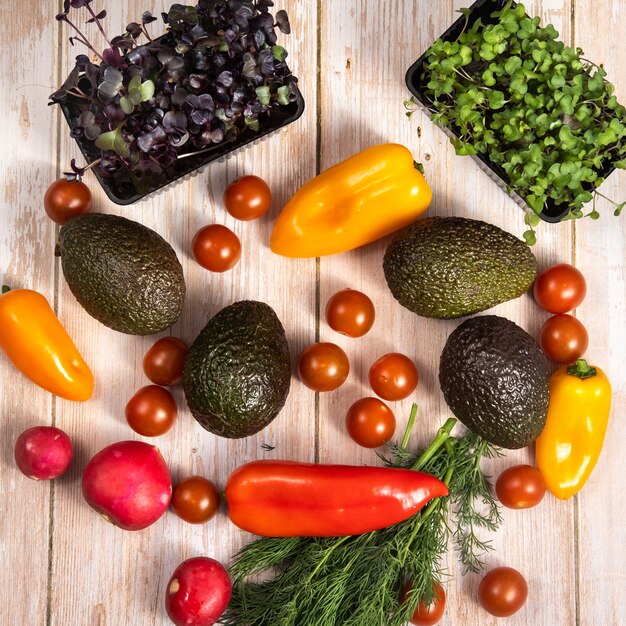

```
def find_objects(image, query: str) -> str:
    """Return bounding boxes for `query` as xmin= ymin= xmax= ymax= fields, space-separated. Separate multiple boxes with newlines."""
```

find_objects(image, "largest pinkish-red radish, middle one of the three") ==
xmin=83 ymin=441 xmax=172 ymax=530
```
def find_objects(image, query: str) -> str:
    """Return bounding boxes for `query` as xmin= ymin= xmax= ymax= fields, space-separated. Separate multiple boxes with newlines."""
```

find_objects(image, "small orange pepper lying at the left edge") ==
xmin=0 ymin=289 xmax=93 ymax=401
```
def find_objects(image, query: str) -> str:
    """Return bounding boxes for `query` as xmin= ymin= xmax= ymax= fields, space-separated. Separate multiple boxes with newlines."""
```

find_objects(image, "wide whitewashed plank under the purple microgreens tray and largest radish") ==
xmin=47 ymin=0 xmax=316 ymax=626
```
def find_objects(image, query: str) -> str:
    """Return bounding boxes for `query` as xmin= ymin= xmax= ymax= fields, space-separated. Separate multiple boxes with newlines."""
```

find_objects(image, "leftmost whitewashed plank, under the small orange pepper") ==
xmin=0 ymin=1 xmax=58 ymax=626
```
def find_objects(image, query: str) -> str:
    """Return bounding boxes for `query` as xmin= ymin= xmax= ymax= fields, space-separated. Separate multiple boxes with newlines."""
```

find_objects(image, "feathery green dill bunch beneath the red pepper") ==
xmin=220 ymin=406 xmax=501 ymax=626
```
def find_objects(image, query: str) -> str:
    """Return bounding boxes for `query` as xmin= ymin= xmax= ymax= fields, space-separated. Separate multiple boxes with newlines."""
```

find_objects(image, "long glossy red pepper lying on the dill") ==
xmin=226 ymin=461 xmax=448 ymax=537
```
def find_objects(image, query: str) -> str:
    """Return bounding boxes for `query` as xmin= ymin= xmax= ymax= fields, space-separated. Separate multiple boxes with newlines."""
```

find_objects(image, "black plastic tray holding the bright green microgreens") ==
xmin=406 ymin=0 xmax=615 ymax=223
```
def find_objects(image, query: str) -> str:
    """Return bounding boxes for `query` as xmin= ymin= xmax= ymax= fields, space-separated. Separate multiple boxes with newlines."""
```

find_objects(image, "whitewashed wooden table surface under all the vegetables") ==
xmin=0 ymin=0 xmax=626 ymax=626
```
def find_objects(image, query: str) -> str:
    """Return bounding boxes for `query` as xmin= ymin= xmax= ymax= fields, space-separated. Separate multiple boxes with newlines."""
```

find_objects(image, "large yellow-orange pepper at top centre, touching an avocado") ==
xmin=270 ymin=143 xmax=432 ymax=258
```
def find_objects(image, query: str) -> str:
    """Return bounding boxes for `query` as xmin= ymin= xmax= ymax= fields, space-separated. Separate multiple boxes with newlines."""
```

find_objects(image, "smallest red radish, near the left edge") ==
xmin=15 ymin=426 xmax=73 ymax=480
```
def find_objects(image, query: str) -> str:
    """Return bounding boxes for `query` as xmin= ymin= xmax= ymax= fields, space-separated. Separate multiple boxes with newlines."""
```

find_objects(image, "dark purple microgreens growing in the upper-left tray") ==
xmin=51 ymin=0 xmax=298 ymax=197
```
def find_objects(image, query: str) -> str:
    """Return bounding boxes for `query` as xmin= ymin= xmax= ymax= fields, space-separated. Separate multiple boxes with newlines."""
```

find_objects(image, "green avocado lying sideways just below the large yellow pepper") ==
xmin=383 ymin=217 xmax=537 ymax=319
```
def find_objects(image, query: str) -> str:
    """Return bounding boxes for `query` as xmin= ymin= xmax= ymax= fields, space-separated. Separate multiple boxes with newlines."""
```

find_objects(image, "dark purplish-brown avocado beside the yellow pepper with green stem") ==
xmin=439 ymin=315 xmax=549 ymax=449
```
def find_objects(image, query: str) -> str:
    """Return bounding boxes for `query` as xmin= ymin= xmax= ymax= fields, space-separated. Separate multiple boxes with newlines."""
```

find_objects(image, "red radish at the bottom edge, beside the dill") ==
xmin=165 ymin=556 xmax=232 ymax=626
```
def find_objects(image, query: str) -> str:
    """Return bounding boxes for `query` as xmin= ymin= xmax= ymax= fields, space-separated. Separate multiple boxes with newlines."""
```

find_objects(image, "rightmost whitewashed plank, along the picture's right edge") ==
xmin=574 ymin=0 xmax=626 ymax=626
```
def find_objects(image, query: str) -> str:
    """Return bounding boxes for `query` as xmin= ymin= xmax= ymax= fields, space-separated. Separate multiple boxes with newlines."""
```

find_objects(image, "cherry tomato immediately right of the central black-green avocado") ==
xmin=298 ymin=342 xmax=350 ymax=391
